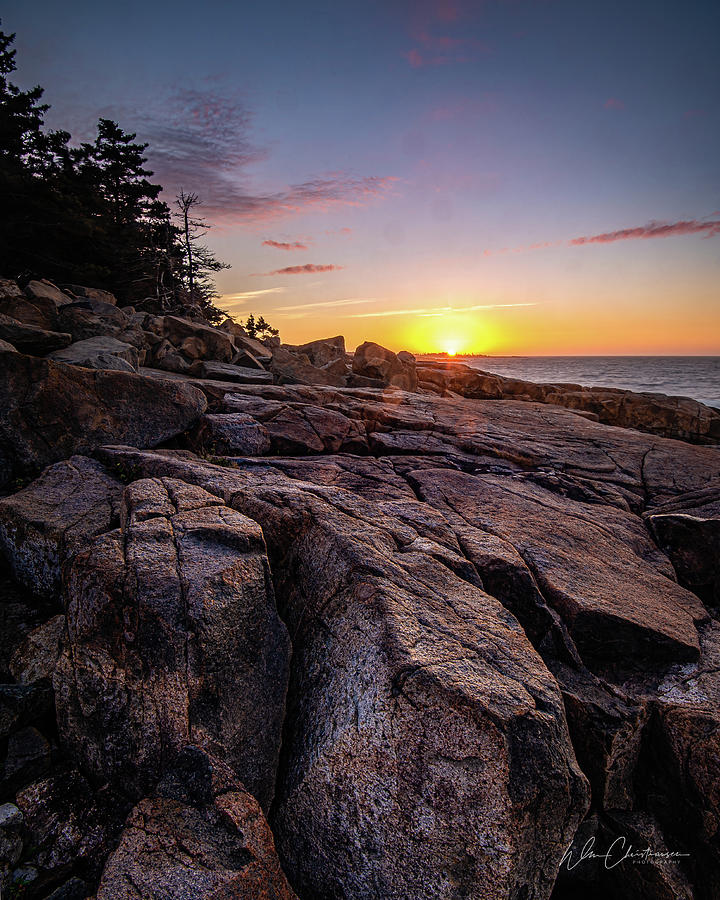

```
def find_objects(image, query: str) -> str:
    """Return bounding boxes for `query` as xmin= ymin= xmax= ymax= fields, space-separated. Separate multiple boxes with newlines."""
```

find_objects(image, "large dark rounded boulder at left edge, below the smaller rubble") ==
xmin=0 ymin=353 xmax=207 ymax=487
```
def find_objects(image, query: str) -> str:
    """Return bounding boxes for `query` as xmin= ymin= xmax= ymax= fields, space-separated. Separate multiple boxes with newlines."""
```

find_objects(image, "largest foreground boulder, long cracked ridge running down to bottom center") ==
xmin=95 ymin=450 xmax=588 ymax=900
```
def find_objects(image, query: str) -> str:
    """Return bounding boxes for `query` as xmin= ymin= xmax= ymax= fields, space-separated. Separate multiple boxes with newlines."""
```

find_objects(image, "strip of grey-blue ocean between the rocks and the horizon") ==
xmin=428 ymin=356 xmax=720 ymax=408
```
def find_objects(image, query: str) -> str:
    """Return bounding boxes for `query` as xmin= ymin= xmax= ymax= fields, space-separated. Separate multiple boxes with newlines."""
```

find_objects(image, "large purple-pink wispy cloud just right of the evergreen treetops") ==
xmin=124 ymin=89 xmax=399 ymax=225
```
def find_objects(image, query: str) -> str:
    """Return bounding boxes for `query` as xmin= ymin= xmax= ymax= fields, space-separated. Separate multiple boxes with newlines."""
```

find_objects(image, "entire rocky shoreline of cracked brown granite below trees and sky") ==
xmin=0 ymin=281 xmax=720 ymax=900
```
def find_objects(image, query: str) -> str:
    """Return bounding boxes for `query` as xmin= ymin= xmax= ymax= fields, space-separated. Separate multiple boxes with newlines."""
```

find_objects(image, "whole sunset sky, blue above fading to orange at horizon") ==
xmin=1 ymin=0 xmax=720 ymax=355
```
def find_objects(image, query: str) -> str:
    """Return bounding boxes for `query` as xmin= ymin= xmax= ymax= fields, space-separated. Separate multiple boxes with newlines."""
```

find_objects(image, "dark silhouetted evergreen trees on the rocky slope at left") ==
xmin=0 ymin=24 xmax=228 ymax=322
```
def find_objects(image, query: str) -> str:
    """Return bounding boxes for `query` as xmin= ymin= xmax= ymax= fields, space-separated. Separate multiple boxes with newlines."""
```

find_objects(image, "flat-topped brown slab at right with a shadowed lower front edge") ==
xmin=413 ymin=468 xmax=707 ymax=668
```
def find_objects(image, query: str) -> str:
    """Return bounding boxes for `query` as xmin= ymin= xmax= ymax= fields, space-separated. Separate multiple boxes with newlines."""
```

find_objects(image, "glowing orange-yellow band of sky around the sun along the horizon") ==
xmin=218 ymin=248 xmax=720 ymax=356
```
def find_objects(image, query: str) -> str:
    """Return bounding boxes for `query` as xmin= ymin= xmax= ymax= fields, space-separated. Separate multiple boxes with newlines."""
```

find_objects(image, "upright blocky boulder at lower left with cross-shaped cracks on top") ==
xmin=54 ymin=479 xmax=289 ymax=808
